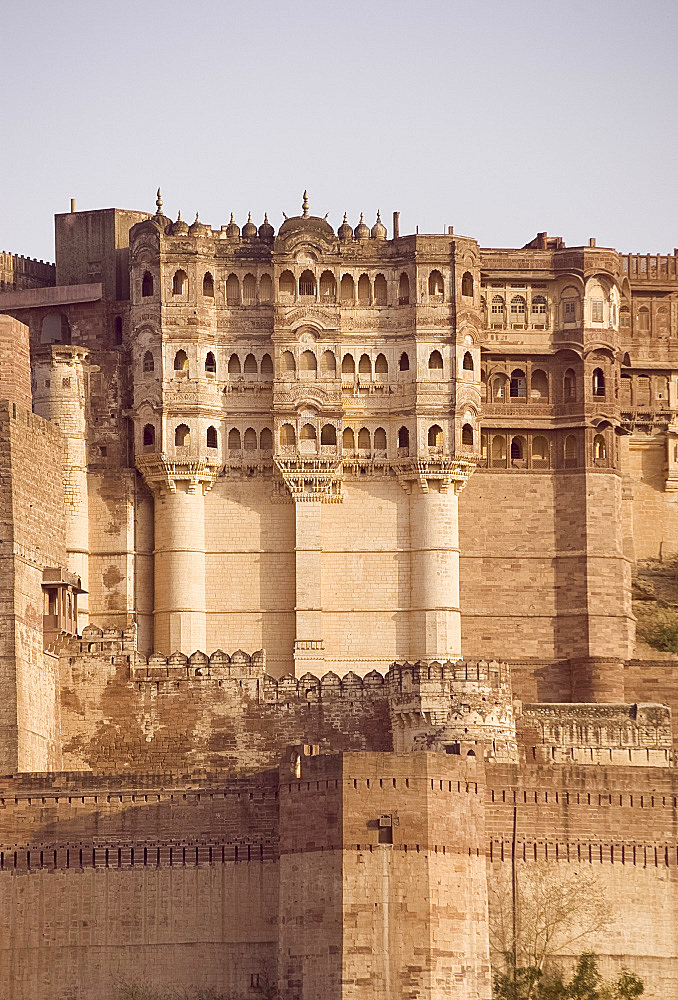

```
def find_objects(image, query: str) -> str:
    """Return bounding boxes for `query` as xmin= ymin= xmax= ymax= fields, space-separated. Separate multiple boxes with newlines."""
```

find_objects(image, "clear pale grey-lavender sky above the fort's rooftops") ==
xmin=0 ymin=0 xmax=678 ymax=259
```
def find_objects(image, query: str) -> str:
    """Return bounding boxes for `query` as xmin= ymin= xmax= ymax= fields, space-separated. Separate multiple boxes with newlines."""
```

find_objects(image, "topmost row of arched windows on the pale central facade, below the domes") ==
xmin=141 ymin=268 xmax=473 ymax=306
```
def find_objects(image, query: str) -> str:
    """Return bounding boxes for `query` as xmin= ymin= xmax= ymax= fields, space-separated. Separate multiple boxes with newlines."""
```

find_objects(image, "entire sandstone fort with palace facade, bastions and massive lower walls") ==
xmin=0 ymin=192 xmax=678 ymax=1000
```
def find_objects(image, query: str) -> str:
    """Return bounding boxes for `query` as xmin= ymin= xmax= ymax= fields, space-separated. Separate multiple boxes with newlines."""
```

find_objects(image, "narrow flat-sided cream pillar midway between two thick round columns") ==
xmin=294 ymin=495 xmax=325 ymax=677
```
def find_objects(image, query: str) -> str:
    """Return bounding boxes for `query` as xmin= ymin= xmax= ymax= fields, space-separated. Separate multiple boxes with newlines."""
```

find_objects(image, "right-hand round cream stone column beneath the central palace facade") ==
xmin=410 ymin=479 xmax=461 ymax=660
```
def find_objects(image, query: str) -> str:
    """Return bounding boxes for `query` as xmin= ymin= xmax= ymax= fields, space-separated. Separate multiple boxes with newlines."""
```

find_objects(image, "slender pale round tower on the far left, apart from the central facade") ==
xmin=34 ymin=344 xmax=89 ymax=632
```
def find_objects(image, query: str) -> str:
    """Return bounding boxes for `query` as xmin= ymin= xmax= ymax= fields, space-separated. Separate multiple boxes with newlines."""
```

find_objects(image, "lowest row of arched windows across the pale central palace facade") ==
xmin=157 ymin=423 xmax=474 ymax=455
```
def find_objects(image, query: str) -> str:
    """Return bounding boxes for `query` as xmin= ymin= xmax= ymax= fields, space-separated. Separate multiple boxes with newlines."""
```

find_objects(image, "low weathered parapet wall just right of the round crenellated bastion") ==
xmin=518 ymin=702 xmax=673 ymax=767
